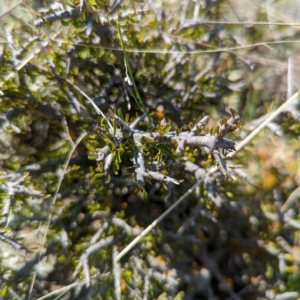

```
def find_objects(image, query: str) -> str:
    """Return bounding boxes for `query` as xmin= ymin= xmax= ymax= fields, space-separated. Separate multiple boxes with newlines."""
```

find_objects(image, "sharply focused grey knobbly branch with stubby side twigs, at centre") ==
xmin=96 ymin=110 xmax=240 ymax=186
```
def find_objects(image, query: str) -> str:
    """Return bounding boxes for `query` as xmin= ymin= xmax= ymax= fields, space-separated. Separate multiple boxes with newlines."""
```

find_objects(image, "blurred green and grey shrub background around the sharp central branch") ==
xmin=0 ymin=0 xmax=300 ymax=300
